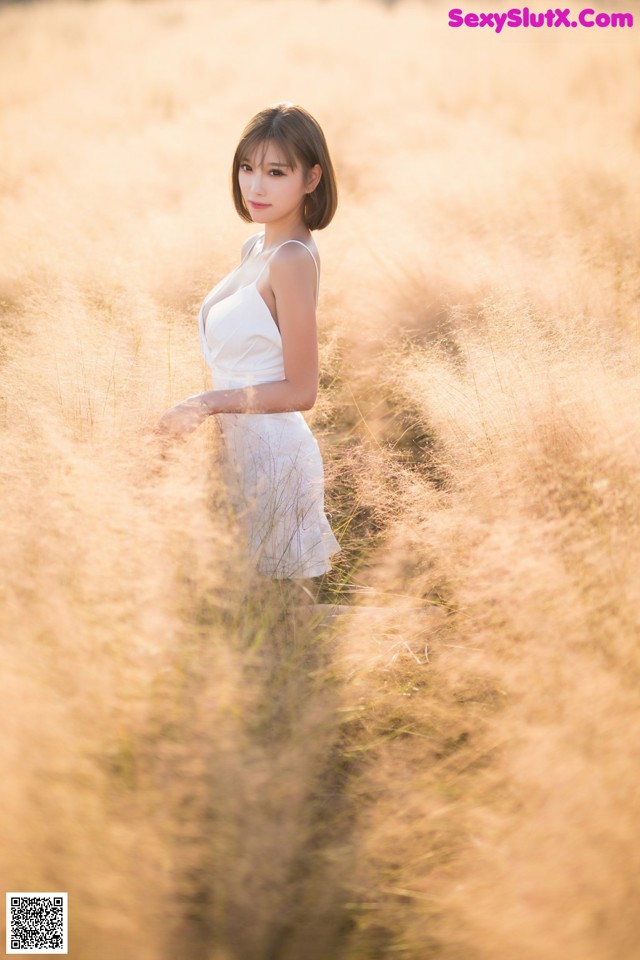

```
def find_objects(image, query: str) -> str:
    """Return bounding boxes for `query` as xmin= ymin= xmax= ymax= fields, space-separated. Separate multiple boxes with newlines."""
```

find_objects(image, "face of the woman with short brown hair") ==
xmin=238 ymin=143 xmax=322 ymax=224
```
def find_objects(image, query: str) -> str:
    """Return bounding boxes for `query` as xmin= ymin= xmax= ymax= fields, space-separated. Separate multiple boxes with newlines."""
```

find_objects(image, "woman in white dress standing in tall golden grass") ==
xmin=156 ymin=103 xmax=341 ymax=579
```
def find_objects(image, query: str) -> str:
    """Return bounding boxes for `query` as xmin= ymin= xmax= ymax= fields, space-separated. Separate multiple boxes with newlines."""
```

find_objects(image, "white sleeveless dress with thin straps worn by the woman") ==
xmin=198 ymin=233 xmax=342 ymax=579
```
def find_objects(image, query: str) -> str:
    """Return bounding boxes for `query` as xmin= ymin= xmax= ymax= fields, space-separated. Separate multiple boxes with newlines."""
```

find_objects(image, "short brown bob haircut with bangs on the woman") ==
xmin=231 ymin=103 xmax=338 ymax=230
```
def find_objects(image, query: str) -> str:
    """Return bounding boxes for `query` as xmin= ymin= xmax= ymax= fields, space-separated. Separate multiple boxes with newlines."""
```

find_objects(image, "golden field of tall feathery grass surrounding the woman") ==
xmin=0 ymin=0 xmax=640 ymax=960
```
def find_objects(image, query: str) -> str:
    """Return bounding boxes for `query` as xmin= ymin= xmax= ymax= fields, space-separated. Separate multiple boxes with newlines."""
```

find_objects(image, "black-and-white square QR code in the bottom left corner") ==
xmin=7 ymin=893 xmax=68 ymax=953
